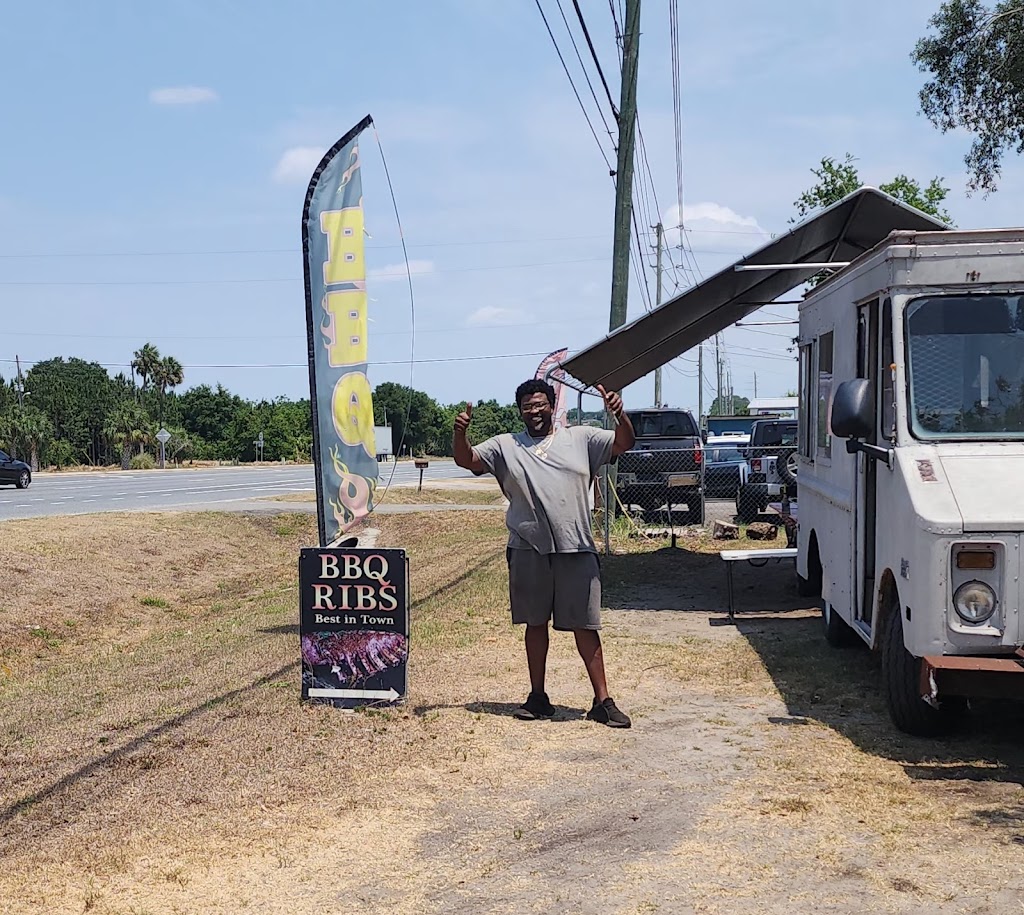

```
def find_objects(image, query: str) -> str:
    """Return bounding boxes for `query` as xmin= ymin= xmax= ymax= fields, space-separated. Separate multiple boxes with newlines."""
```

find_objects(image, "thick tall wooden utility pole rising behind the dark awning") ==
xmin=608 ymin=0 xmax=640 ymax=331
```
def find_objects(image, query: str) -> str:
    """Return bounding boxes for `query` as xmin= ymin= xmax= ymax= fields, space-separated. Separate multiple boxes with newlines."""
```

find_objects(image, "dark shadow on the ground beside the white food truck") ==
xmin=602 ymin=547 xmax=1024 ymax=786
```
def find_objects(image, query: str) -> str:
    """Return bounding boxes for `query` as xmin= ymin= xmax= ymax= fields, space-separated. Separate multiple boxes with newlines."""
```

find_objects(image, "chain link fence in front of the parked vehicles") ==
xmin=596 ymin=442 xmax=799 ymax=550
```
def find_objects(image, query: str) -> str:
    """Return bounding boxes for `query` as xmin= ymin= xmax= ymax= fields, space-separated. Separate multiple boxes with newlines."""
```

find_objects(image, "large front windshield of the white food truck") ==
xmin=905 ymin=295 xmax=1024 ymax=439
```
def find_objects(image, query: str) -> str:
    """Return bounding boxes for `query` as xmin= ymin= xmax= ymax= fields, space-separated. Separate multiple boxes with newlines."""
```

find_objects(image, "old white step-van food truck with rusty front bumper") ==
xmin=797 ymin=229 xmax=1024 ymax=735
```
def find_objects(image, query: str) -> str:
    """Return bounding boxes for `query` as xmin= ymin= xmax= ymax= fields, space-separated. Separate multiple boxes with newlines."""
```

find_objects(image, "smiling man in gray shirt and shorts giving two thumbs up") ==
xmin=453 ymin=379 xmax=635 ymax=728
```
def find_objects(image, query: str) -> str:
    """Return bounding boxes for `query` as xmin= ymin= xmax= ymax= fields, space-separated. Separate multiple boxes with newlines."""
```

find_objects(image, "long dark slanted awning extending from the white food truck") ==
xmin=563 ymin=187 xmax=946 ymax=391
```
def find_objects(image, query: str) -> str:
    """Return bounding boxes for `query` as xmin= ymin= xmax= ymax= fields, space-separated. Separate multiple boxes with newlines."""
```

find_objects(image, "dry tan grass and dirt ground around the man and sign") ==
xmin=0 ymin=512 xmax=1024 ymax=915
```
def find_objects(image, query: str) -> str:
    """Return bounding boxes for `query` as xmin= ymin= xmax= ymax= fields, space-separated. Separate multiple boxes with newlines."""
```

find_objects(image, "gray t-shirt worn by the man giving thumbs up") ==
xmin=473 ymin=426 xmax=615 ymax=555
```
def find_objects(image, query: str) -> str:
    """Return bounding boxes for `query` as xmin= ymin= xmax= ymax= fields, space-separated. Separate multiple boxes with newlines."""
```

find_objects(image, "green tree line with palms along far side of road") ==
xmin=0 ymin=354 xmax=522 ymax=470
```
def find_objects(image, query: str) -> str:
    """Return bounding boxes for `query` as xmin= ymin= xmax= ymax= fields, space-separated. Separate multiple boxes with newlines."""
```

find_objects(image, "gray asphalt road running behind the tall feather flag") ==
xmin=0 ymin=461 xmax=471 ymax=521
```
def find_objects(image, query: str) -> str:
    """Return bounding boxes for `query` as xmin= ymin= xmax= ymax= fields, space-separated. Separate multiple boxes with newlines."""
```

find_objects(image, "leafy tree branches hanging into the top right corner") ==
xmin=910 ymin=0 xmax=1024 ymax=193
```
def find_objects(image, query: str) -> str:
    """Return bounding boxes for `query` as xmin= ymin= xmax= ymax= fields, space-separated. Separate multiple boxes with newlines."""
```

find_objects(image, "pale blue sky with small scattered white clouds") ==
xmin=0 ymin=0 xmax=1024 ymax=415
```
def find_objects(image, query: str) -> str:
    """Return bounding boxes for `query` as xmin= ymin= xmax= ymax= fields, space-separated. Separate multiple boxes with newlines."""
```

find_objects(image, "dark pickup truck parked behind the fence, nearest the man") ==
xmin=616 ymin=407 xmax=705 ymax=524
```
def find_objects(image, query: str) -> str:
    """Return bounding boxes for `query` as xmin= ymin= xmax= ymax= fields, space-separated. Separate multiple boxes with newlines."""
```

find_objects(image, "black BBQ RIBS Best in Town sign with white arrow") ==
xmin=299 ymin=548 xmax=409 ymax=708
